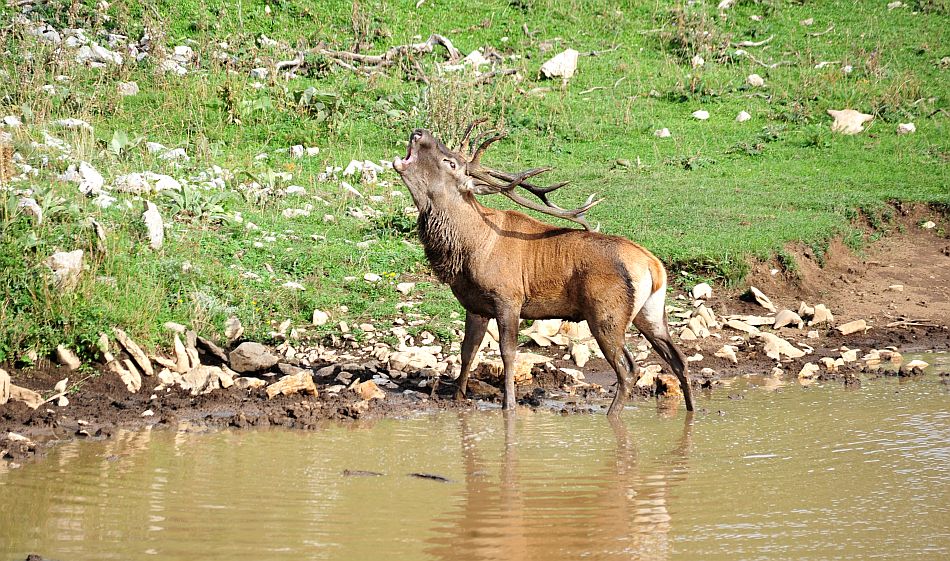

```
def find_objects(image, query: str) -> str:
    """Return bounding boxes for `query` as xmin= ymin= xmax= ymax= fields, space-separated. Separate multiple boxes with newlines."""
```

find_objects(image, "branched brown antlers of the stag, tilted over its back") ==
xmin=459 ymin=119 xmax=603 ymax=230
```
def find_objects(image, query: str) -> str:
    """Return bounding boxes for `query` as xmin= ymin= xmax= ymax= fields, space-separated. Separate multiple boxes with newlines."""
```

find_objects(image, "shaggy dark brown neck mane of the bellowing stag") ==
xmin=418 ymin=195 xmax=492 ymax=284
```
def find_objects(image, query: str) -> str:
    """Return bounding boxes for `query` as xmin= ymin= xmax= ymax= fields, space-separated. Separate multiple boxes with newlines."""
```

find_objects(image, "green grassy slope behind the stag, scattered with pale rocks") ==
xmin=0 ymin=0 xmax=950 ymax=361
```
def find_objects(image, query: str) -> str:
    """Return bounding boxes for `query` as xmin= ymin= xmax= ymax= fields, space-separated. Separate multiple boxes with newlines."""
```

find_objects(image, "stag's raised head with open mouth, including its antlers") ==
xmin=393 ymin=123 xmax=603 ymax=230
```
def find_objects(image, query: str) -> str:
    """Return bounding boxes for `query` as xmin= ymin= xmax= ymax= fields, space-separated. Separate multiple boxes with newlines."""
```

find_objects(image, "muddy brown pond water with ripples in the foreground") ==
xmin=0 ymin=354 xmax=950 ymax=561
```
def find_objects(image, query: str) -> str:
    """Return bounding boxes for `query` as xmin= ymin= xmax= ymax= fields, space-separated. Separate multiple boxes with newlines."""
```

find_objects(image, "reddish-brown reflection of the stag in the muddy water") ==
xmin=427 ymin=411 xmax=693 ymax=561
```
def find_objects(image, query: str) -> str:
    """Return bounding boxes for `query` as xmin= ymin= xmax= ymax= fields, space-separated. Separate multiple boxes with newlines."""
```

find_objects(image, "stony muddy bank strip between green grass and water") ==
xmin=0 ymin=209 xmax=950 ymax=461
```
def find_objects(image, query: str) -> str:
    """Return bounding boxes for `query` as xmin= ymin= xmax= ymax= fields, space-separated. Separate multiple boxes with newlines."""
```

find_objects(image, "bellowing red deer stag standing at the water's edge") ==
xmin=393 ymin=127 xmax=693 ymax=417
